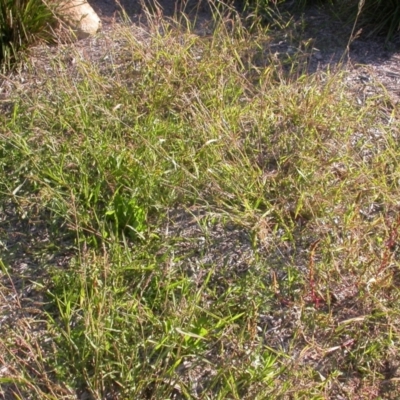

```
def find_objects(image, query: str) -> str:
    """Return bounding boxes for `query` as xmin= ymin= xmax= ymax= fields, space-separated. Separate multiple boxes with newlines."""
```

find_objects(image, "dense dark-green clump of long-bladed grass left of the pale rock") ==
xmin=0 ymin=0 xmax=54 ymax=70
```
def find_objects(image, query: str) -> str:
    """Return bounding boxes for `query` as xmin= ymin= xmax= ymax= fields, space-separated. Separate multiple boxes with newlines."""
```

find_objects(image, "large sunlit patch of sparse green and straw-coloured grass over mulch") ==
xmin=0 ymin=3 xmax=400 ymax=399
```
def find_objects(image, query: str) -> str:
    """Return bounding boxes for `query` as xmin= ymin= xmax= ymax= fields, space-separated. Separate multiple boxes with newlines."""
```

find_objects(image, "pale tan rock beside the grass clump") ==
xmin=58 ymin=0 xmax=101 ymax=40
